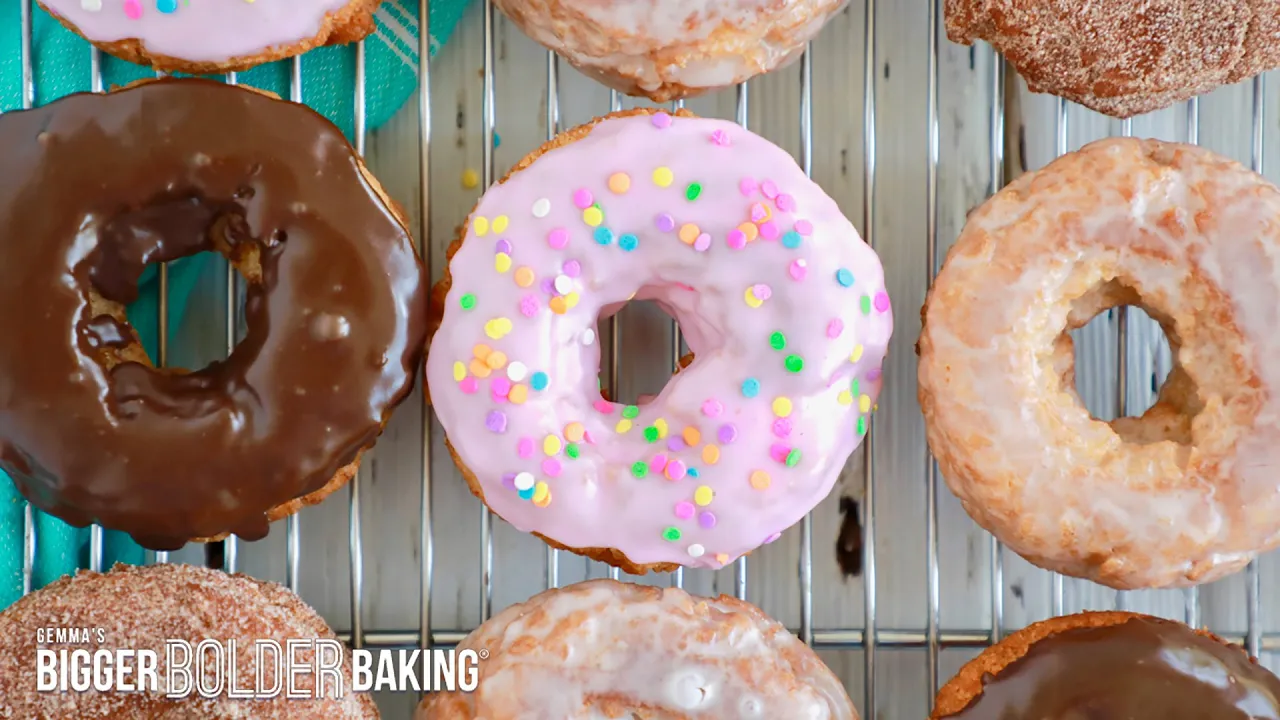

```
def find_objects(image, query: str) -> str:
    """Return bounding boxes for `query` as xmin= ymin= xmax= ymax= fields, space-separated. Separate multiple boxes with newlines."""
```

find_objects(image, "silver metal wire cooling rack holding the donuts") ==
xmin=12 ymin=0 xmax=1280 ymax=719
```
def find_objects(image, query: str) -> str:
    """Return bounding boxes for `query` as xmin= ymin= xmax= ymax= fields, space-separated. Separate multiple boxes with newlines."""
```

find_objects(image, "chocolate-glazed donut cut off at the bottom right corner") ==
xmin=931 ymin=612 xmax=1280 ymax=720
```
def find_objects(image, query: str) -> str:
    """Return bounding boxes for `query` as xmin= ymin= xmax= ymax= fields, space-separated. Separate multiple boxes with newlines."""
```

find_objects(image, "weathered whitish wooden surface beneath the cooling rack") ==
xmin=129 ymin=0 xmax=1280 ymax=720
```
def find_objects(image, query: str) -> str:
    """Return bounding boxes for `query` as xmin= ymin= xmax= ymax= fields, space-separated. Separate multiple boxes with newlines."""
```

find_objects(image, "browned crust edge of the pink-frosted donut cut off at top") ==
xmin=36 ymin=0 xmax=383 ymax=76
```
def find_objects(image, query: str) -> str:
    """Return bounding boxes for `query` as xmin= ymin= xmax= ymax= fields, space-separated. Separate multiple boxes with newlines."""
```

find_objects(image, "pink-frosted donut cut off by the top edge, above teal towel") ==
xmin=37 ymin=0 xmax=381 ymax=74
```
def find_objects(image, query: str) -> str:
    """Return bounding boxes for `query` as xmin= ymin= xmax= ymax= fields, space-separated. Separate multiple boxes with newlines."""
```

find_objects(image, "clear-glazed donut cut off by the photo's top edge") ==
xmin=494 ymin=0 xmax=849 ymax=102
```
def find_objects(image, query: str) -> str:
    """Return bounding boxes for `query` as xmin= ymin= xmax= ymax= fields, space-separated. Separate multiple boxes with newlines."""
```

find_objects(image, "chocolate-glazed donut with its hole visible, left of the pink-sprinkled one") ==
xmin=0 ymin=79 xmax=428 ymax=550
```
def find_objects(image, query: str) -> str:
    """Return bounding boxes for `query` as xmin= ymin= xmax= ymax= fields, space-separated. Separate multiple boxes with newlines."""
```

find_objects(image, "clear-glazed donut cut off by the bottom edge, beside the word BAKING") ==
xmin=415 ymin=580 xmax=858 ymax=720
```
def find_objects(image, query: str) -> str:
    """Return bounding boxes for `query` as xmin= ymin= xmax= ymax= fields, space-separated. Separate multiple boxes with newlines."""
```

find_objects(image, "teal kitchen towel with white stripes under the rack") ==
xmin=0 ymin=0 xmax=470 ymax=609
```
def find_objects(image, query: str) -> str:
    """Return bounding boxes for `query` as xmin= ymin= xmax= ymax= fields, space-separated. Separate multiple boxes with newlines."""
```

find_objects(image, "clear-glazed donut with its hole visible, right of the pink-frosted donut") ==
xmin=918 ymin=138 xmax=1280 ymax=589
